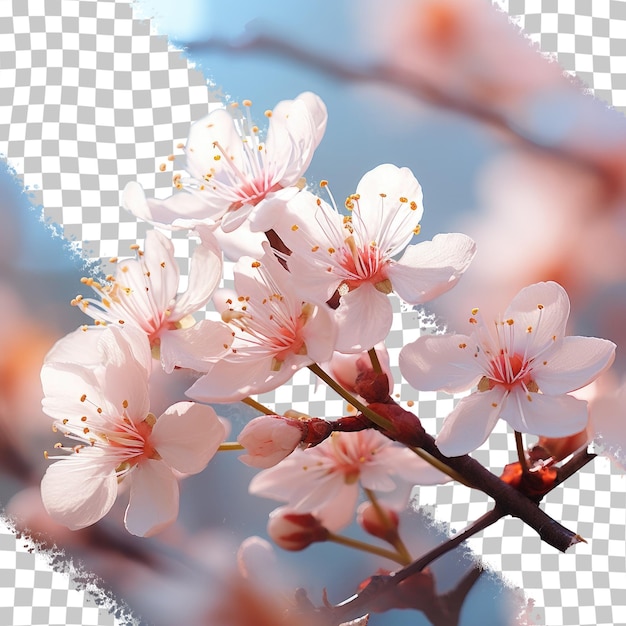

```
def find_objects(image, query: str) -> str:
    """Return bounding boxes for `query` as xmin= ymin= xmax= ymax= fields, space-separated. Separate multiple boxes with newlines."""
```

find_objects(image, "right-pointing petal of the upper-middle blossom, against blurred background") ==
xmin=387 ymin=233 xmax=476 ymax=304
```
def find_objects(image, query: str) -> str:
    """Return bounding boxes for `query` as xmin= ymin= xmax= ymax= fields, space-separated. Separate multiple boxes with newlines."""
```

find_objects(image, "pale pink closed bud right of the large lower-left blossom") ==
xmin=237 ymin=415 xmax=306 ymax=468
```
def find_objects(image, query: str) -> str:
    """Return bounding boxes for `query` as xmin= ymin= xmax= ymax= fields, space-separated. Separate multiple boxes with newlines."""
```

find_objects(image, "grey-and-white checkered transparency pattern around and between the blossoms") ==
xmin=0 ymin=0 xmax=626 ymax=626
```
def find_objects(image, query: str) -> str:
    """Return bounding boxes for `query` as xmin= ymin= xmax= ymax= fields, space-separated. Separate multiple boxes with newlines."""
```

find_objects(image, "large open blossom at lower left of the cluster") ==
xmin=41 ymin=326 xmax=226 ymax=536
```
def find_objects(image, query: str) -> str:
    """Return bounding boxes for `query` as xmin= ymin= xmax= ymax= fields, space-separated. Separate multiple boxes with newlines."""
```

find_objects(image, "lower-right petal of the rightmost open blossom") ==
xmin=500 ymin=389 xmax=588 ymax=437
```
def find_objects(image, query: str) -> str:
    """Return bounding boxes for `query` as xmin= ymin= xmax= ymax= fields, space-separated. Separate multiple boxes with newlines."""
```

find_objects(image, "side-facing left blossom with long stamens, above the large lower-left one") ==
xmin=72 ymin=228 xmax=232 ymax=373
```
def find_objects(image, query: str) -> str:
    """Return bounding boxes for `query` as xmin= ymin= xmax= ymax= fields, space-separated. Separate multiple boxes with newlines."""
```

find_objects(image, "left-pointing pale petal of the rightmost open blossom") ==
xmin=399 ymin=335 xmax=482 ymax=393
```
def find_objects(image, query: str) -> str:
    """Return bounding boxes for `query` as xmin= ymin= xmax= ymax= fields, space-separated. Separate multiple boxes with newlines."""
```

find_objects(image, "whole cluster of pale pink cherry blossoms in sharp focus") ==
xmin=41 ymin=93 xmax=615 ymax=564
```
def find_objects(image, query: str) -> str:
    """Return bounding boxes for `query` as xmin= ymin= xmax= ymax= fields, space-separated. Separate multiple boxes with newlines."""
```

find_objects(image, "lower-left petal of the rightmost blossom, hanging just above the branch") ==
xmin=435 ymin=387 xmax=506 ymax=456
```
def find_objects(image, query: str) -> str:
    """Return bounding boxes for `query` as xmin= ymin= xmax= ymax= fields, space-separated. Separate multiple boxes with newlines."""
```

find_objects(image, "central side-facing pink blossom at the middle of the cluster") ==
xmin=187 ymin=243 xmax=336 ymax=402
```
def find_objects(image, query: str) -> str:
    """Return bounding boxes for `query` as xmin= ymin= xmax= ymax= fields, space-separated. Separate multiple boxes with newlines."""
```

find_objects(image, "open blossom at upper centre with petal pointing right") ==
xmin=276 ymin=164 xmax=475 ymax=352
